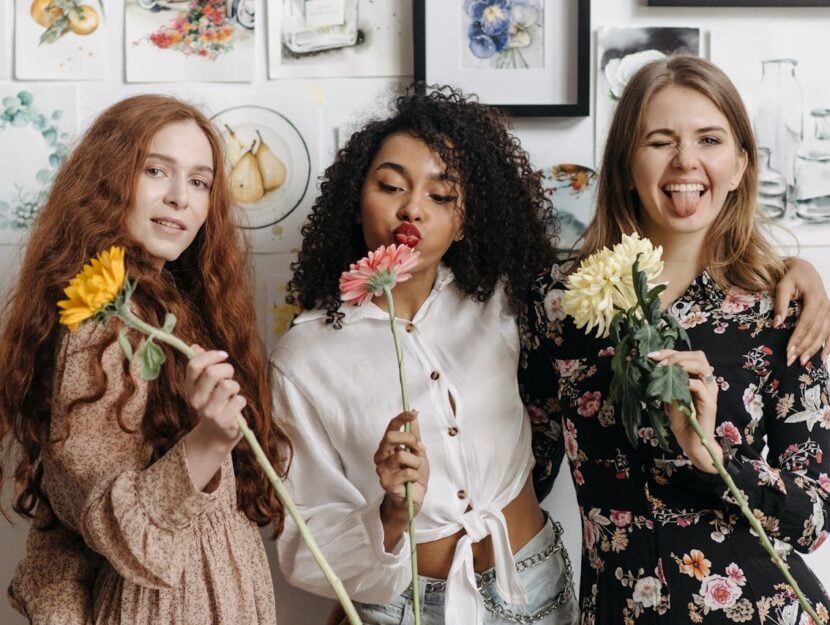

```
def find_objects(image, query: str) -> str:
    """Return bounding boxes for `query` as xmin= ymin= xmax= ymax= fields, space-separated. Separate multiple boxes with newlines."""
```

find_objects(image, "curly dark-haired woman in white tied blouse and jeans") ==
xmin=274 ymin=89 xmax=576 ymax=624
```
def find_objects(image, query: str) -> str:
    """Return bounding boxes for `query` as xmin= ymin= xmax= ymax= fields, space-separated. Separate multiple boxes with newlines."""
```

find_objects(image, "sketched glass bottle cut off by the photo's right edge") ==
xmin=795 ymin=109 xmax=830 ymax=223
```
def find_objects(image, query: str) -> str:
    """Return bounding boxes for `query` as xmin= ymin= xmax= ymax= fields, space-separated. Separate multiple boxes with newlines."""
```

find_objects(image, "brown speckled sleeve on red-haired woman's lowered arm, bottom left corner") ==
xmin=8 ymin=502 xmax=100 ymax=625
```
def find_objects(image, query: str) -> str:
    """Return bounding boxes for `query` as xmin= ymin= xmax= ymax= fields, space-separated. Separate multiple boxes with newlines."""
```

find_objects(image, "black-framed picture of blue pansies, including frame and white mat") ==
xmin=413 ymin=0 xmax=591 ymax=117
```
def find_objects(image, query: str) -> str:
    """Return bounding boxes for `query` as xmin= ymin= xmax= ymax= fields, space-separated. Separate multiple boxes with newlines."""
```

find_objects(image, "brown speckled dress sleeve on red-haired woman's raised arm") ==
xmin=43 ymin=324 xmax=218 ymax=588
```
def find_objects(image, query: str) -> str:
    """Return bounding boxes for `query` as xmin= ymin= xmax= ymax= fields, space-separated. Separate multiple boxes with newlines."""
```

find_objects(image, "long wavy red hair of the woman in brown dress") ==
xmin=0 ymin=95 xmax=291 ymax=533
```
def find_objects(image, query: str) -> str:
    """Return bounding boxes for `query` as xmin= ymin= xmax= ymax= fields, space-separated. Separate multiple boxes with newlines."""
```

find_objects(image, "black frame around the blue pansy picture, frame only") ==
xmin=412 ymin=0 xmax=591 ymax=117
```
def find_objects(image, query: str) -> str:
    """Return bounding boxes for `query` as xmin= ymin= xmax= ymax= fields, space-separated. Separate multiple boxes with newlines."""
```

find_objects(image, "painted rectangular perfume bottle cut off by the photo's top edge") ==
xmin=282 ymin=0 xmax=358 ymax=54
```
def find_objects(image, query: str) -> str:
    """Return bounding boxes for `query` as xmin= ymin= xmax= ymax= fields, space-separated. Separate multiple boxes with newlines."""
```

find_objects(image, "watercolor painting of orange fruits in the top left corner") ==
xmin=14 ymin=0 xmax=107 ymax=80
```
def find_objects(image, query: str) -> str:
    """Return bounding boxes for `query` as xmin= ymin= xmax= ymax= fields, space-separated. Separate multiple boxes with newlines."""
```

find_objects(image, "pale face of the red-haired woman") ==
xmin=126 ymin=121 xmax=214 ymax=267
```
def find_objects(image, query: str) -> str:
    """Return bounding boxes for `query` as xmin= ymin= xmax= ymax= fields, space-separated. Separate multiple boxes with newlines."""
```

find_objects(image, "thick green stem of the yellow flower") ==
xmin=116 ymin=307 xmax=361 ymax=625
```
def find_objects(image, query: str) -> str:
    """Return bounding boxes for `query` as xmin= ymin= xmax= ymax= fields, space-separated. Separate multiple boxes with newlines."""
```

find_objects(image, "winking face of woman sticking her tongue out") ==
xmin=631 ymin=86 xmax=747 ymax=240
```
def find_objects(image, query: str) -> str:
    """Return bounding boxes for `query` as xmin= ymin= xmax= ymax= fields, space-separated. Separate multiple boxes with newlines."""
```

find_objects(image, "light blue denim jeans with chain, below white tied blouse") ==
xmin=355 ymin=520 xmax=579 ymax=625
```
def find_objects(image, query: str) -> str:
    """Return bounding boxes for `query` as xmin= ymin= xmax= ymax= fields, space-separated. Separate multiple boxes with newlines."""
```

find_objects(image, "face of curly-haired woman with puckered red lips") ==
xmin=360 ymin=133 xmax=464 ymax=280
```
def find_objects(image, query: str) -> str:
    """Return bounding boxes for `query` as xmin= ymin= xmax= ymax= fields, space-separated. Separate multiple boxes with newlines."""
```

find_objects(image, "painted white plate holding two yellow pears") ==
xmin=213 ymin=105 xmax=311 ymax=229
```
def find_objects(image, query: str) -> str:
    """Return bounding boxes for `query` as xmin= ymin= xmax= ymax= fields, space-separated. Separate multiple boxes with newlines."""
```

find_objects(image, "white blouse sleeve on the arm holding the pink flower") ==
xmin=274 ymin=372 xmax=412 ymax=604
